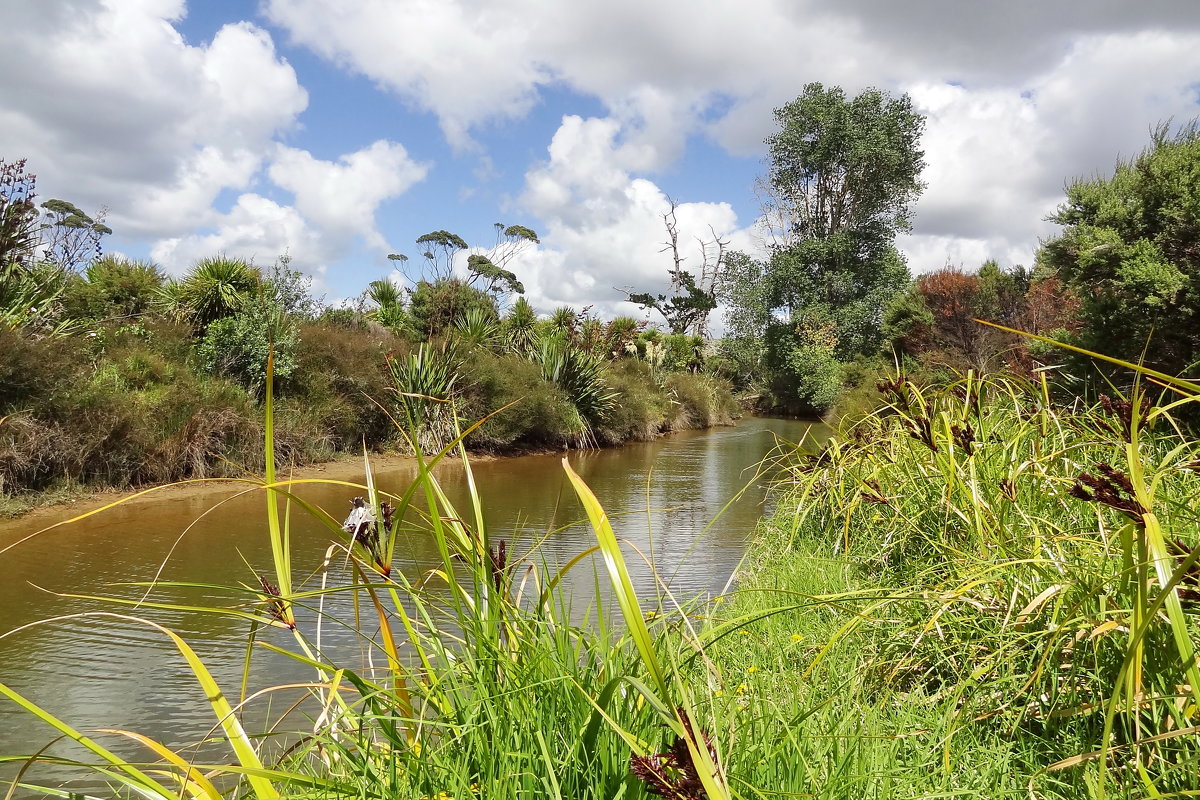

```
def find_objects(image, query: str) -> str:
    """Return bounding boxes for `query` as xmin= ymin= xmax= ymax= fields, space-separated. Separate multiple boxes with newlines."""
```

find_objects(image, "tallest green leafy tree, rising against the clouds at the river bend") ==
xmin=726 ymin=83 xmax=925 ymax=410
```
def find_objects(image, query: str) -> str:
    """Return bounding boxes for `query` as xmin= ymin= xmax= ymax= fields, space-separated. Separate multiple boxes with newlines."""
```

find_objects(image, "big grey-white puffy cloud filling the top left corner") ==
xmin=0 ymin=0 xmax=307 ymax=236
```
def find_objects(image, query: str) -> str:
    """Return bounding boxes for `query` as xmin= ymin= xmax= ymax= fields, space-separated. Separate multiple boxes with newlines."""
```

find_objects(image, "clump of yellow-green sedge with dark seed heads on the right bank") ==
xmin=752 ymin=374 xmax=1198 ymax=798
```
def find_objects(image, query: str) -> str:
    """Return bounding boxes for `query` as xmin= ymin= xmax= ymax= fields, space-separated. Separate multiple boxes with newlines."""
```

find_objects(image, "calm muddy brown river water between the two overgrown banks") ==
xmin=0 ymin=417 xmax=823 ymax=796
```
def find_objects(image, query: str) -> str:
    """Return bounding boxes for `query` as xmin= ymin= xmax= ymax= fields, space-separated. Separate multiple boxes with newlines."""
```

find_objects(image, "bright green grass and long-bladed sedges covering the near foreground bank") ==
xmin=0 ymin=357 xmax=1200 ymax=800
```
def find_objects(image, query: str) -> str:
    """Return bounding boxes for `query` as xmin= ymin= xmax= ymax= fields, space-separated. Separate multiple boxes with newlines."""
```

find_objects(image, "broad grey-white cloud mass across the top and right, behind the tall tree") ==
xmin=265 ymin=0 xmax=1200 ymax=284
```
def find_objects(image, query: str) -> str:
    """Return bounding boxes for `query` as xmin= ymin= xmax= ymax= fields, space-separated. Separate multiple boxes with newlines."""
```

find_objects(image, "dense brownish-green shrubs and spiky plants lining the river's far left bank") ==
xmin=0 ymin=259 xmax=736 ymax=506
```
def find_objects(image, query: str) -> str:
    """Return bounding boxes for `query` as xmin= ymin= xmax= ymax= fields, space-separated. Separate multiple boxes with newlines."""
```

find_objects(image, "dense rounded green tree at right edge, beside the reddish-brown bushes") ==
xmin=1038 ymin=121 xmax=1200 ymax=373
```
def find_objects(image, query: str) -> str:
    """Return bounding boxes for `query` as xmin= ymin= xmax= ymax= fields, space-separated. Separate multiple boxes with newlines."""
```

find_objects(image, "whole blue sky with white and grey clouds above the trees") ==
xmin=0 ymin=0 xmax=1200 ymax=317
